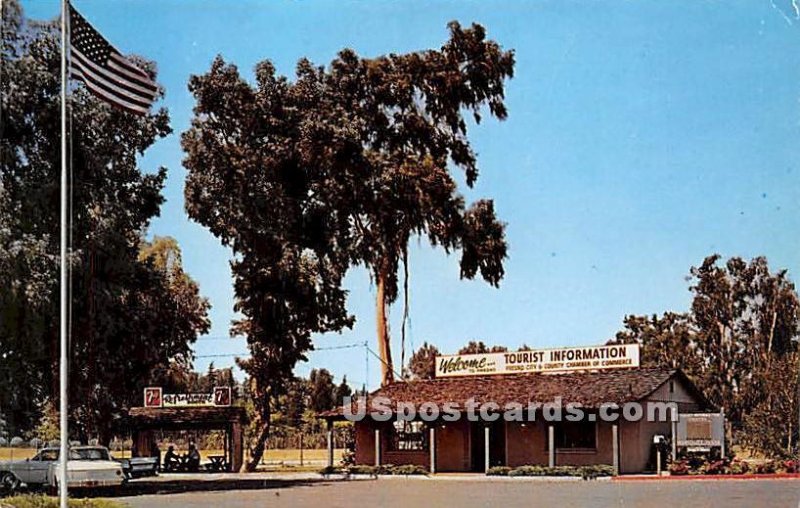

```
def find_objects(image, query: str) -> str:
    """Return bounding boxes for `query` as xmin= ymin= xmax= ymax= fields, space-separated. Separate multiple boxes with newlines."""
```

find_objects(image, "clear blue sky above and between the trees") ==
xmin=18 ymin=0 xmax=800 ymax=387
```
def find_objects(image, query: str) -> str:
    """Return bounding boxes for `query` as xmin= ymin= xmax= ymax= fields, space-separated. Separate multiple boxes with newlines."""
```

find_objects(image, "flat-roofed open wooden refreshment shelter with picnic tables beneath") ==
xmin=128 ymin=406 xmax=247 ymax=471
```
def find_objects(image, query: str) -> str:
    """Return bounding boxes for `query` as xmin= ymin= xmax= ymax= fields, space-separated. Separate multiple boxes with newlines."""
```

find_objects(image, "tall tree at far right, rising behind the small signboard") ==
xmin=690 ymin=254 xmax=800 ymax=428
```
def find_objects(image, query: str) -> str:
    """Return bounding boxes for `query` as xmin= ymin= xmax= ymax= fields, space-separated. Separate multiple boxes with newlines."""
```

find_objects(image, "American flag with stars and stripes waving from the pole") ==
xmin=69 ymin=5 xmax=158 ymax=115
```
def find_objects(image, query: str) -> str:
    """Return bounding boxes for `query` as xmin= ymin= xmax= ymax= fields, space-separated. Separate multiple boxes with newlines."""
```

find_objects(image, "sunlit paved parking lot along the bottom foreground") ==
xmin=115 ymin=478 xmax=800 ymax=508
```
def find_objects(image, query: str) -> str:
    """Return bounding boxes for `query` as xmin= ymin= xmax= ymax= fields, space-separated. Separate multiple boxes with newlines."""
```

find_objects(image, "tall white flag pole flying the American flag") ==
xmin=58 ymin=0 xmax=69 ymax=508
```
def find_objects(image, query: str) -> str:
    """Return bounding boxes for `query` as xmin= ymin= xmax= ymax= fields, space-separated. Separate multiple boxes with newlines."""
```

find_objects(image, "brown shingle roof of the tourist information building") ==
xmin=319 ymin=368 xmax=708 ymax=418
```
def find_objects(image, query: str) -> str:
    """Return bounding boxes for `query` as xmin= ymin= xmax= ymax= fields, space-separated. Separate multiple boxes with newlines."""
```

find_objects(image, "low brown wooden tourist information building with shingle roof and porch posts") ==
xmin=320 ymin=367 xmax=715 ymax=474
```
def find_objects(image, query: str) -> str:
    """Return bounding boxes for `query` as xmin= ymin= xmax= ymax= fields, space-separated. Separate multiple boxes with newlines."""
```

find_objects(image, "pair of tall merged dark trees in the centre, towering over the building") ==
xmin=182 ymin=23 xmax=514 ymax=468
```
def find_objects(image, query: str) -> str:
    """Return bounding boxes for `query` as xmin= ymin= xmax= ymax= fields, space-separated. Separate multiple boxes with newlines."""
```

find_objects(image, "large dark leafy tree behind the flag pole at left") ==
xmin=0 ymin=0 xmax=208 ymax=441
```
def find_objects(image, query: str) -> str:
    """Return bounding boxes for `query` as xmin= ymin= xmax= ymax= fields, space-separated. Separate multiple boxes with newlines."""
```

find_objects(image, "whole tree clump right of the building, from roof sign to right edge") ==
xmin=611 ymin=254 xmax=800 ymax=457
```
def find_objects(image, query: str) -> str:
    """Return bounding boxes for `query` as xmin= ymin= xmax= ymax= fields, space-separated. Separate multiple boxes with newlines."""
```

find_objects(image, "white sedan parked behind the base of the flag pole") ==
xmin=0 ymin=446 xmax=126 ymax=494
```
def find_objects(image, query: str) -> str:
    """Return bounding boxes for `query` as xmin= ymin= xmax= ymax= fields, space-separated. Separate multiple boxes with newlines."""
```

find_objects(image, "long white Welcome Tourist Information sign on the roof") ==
xmin=436 ymin=344 xmax=639 ymax=377
